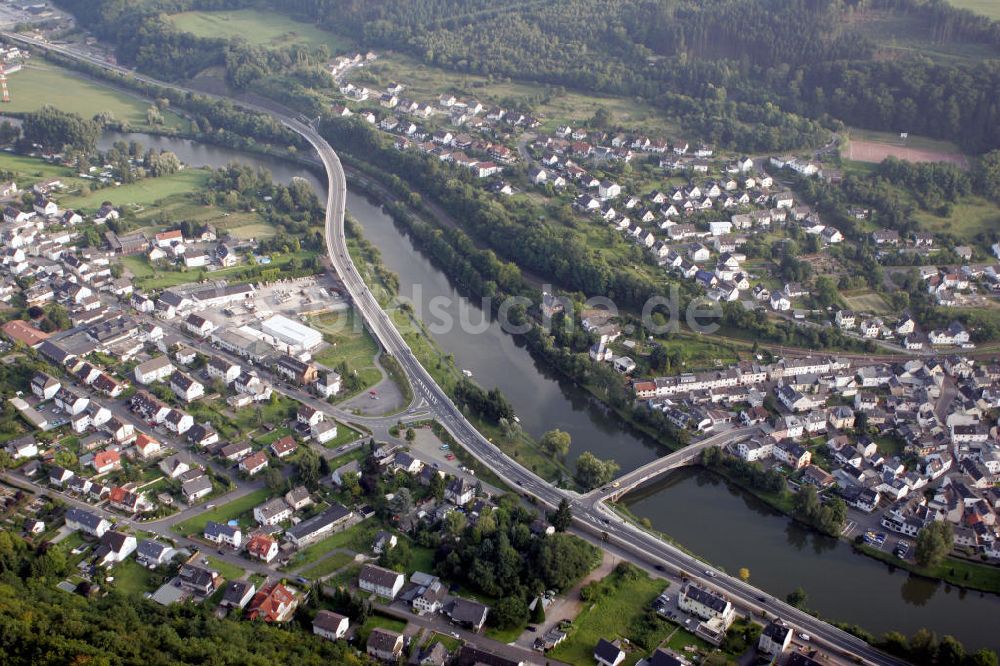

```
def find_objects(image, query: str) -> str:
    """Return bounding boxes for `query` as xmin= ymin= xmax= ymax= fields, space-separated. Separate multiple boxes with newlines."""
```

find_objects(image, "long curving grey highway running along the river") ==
xmin=3 ymin=33 xmax=905 ymax=666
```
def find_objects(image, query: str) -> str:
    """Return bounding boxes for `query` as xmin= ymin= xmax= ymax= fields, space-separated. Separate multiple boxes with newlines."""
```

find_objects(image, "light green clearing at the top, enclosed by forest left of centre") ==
xmin=167 ymin=9 xmax=353 ymax=54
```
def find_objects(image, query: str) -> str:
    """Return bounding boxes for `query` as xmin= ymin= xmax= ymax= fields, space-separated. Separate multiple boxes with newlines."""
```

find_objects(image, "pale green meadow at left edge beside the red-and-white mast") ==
xmin=4 ymin=60 xmax=187 ymax=128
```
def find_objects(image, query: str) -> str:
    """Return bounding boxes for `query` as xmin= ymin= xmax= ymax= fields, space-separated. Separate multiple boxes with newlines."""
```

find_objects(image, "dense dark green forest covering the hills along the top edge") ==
xmin=57 ymin=0 xmax=1000 ymax=153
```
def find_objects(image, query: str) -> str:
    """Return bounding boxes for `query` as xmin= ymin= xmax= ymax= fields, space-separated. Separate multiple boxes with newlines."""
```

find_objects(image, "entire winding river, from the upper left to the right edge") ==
xmin=100 ymin=133 xmax=1000 ymax=650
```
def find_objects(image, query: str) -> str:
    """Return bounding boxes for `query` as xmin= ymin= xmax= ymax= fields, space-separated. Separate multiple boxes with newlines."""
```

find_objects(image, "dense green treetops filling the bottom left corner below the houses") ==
xmin=0 ymin=531 xmax=371 ymax=666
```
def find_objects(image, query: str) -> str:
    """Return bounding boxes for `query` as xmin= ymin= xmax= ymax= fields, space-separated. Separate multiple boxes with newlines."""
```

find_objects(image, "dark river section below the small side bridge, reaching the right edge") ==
xmin=625 ymin=469 xmax=1000 ymax=650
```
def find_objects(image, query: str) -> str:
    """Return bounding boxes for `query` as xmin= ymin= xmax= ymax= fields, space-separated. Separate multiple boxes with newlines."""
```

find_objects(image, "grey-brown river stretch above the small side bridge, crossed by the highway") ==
xmin=98 ymin=132 xmax=657 ymax=471
